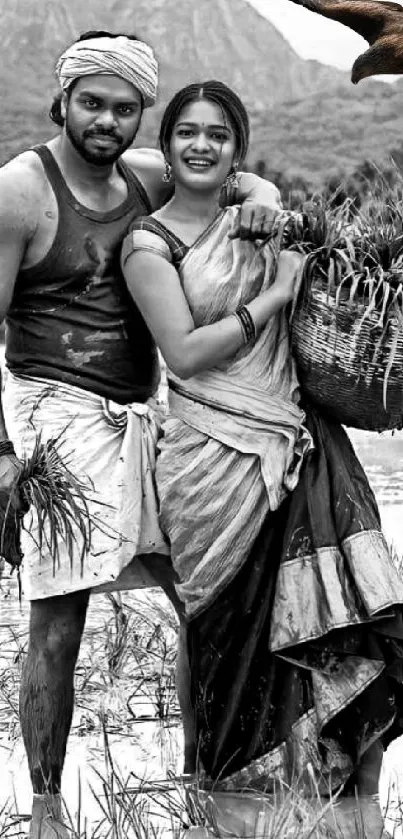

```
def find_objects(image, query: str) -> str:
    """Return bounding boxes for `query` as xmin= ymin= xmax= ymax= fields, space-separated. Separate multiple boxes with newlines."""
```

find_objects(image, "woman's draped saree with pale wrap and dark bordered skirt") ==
xmin=128 ymin=208 xmax=403 ymax=792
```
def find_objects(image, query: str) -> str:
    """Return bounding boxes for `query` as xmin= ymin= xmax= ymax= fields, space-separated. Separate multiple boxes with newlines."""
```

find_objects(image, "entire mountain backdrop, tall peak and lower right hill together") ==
xmin=0 ymin=0 xmax=403 ymax=186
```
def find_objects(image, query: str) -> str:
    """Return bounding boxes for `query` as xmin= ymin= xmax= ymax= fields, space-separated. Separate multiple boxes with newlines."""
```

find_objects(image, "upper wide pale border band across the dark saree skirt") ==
xmin=270 ymin=530 xmax=403 ymax=652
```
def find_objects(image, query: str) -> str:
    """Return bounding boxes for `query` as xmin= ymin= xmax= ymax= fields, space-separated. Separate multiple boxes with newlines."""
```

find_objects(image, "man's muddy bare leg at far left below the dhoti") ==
xmin=20 ymin=591 xmax=89 ymax=839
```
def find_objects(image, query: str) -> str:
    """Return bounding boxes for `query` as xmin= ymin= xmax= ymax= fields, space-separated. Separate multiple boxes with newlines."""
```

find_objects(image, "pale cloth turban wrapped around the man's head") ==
xmin=56 ymin=35 xmax=158 ymax=108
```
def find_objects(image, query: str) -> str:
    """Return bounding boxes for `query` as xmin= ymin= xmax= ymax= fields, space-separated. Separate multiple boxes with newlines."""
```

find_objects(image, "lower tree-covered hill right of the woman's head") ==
xmin=249 ymin=78 xmax=403 ymax=188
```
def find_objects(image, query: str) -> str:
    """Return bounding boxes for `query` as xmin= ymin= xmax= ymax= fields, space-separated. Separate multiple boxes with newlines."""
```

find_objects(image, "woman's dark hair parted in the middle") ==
xmin=159 ymin=79 xmax=250 ymax=164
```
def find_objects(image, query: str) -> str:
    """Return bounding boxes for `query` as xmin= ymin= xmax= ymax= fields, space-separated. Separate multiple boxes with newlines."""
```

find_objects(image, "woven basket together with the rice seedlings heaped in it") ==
xmin=279 ymin=187 xmax=403 ymax=431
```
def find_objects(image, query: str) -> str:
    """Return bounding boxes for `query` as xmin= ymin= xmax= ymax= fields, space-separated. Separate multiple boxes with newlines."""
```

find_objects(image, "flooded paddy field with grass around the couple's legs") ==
xmin=0 ymin=432 xmax=403 ymax=839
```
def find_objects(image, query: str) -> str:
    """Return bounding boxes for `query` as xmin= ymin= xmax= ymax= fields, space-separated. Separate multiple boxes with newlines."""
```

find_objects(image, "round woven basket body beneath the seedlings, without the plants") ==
xmin=291 ymin=271 xmax=403 ymax=431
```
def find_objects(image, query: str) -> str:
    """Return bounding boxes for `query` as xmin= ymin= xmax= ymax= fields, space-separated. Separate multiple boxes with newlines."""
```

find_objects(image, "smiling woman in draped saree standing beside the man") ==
xmin=122 ymin=82 xmax=403 ymax=804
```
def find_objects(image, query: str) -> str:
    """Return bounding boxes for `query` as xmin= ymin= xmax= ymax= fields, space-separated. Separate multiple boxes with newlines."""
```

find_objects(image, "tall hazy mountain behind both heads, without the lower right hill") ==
xmin=0 ymin=0 xmax=345 ymax=162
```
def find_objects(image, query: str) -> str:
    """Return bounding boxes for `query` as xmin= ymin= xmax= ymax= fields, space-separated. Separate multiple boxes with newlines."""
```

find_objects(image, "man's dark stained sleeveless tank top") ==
xmin=6 ymin=146 xmax=159 ymax=404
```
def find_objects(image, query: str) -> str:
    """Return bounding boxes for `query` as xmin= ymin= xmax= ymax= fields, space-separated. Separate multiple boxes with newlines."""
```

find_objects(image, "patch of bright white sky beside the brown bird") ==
xmin=248 ymin=0 xmax=403 ymax=74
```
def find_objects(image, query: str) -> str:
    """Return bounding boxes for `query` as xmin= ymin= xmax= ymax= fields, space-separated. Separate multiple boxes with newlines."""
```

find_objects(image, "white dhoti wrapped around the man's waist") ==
xmin=4 ymin=373 xmax=169 ymax=600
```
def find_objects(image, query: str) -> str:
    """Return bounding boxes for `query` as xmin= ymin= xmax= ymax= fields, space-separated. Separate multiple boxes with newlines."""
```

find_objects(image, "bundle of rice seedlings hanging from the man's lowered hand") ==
xmin=0 ymin=435 xmax=92 ymax=584
